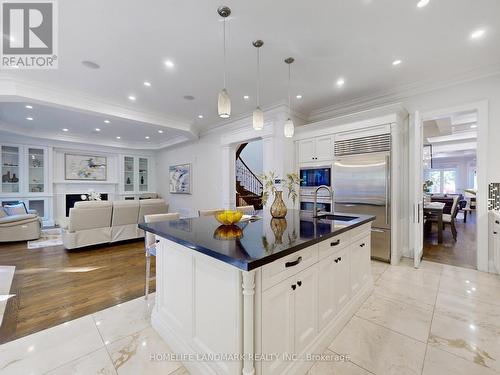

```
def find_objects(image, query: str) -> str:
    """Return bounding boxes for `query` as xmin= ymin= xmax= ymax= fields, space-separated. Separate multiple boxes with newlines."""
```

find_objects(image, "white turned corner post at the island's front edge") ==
xmin=241 ymin=271 xmax=255 ymax=375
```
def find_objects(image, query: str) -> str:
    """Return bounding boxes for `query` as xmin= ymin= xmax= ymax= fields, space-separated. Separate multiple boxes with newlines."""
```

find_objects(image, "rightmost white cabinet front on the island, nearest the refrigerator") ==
xmin=350 ymin=235 xmax=371 ymax=295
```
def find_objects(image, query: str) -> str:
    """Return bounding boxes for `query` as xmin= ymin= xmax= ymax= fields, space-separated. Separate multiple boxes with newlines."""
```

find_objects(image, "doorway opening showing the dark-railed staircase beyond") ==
xmin=235 ymin=139 xmax=264 ymax=210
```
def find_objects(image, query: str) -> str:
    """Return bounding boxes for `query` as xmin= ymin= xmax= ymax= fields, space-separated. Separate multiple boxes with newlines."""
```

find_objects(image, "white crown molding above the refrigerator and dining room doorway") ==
xmin=307 ymin=64 xmax=500 ymax=123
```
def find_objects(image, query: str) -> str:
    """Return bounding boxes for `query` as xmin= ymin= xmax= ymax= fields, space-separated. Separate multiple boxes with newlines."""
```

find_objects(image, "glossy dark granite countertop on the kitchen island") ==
xmin=139 ymin=210 xmax=375 ymax=271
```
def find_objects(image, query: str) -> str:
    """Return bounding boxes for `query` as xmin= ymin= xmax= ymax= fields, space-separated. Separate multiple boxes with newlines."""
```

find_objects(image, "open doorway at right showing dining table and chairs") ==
xmin=421 ymin=110 xmax=479 ymax=269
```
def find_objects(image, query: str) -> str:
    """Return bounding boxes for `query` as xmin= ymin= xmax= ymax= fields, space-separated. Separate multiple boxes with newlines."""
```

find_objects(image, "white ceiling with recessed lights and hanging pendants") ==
xmin=0 ymin=0 xmax=500 ymax=147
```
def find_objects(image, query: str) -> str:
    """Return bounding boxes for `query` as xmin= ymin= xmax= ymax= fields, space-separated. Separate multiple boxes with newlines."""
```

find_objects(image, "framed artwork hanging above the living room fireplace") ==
xmin=64 ymin=154 xmax=108 ymax=181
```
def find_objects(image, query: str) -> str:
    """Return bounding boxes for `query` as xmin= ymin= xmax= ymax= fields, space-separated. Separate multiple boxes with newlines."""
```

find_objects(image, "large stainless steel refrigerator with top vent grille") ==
xmin=332 ymin=134 xmax=391 ymax=262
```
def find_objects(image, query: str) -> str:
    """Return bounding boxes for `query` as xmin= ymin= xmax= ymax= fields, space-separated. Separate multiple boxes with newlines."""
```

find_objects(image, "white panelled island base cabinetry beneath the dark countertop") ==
xmin=152 ymin=222 xmax=373 ymax=375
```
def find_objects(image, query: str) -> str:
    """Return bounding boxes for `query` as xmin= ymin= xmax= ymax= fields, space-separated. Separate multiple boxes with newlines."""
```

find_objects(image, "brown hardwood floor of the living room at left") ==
xmin=0 ymin=240 xmax=155 ymax=343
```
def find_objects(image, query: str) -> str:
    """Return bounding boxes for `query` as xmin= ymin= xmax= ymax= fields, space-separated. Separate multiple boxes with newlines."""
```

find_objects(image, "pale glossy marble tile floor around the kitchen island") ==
xmin=0 ymin=260 xmax=500 ymax=375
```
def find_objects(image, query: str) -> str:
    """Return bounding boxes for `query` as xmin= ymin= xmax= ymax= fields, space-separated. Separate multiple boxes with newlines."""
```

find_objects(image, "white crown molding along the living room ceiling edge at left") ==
xmin=0 ymin=74 xmax=198 ymax=139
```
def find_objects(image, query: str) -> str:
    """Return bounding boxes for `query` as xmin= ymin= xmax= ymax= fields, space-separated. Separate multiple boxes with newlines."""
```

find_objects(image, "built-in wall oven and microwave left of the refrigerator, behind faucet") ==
xmin=299 ymin=165 xmax=333 ymax=212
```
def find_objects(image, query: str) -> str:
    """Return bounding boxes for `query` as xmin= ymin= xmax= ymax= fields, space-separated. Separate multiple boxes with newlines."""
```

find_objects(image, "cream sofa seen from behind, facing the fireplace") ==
xmin=62 ymin=199 xmax=168 ymax=249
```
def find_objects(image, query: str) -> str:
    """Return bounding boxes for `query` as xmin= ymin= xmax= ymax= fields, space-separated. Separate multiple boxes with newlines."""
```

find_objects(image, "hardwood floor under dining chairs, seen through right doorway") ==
xmin=423 ymin=212 xmax=477 ymax=269
